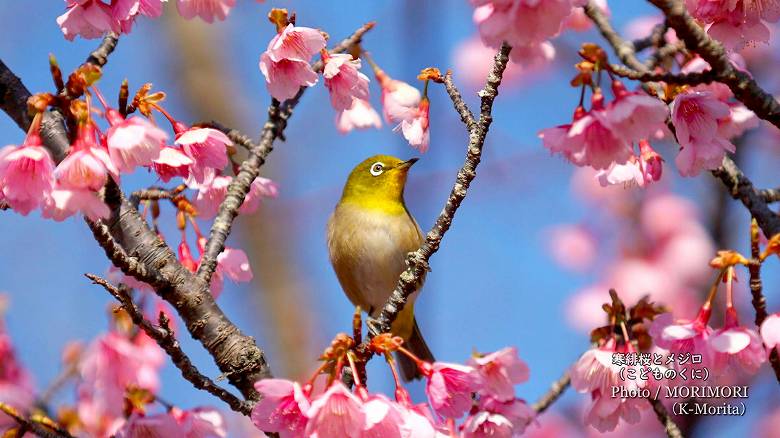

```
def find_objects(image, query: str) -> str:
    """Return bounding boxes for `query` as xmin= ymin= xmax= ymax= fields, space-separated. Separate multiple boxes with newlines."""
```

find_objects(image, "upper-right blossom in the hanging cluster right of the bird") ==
xmin=605 ymin=80 xmax=669 ymax=142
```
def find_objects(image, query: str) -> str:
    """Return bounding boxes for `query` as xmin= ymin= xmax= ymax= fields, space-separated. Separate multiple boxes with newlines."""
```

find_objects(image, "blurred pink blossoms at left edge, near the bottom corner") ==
xmin=0 ymin=294 xmax=35 ymax=435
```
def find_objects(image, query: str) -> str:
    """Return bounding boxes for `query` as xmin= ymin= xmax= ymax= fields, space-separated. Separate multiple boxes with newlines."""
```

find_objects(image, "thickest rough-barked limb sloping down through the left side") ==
xmin=0 ymin=45 xmax=271 ymax=399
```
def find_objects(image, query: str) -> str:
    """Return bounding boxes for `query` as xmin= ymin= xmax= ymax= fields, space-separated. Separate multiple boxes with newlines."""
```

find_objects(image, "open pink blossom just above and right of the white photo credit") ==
xmin=708 ymin=307 xmax=767 ymax=375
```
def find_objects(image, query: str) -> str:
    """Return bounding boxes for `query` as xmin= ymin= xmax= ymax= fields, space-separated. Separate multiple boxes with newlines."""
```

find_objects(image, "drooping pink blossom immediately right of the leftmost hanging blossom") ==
xmin=54 ymin=126 xmax=119 ymax=191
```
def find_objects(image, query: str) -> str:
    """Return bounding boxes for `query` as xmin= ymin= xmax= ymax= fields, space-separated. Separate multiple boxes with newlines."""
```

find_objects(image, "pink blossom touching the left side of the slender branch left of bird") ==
xmin=175 ymin=124 xmax=233 ymax=182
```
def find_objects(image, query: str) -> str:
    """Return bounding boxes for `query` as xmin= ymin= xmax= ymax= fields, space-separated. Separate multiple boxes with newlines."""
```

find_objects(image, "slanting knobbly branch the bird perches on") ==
xmin=361 ymin=43 xmax=512 ymax=338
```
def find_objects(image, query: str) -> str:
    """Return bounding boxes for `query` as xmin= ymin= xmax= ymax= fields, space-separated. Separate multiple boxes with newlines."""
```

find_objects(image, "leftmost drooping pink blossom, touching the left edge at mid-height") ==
xmin=0 ymin=134 xmax=54 ymax=215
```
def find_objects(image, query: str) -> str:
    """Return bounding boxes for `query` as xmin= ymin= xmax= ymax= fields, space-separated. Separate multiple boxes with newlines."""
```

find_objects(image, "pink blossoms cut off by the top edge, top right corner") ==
xmin=685 ymin=0 xmax=780 ymax=49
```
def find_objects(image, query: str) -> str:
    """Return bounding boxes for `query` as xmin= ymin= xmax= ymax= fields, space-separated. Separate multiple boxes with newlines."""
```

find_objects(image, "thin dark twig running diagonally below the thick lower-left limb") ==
xmin=85 ymin=274 xmax=252 ymax=415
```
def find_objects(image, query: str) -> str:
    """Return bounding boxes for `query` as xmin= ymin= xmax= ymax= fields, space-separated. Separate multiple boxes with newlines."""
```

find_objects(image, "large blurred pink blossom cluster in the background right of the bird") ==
xmin=549 ymin=187 xmax=715 ymax=331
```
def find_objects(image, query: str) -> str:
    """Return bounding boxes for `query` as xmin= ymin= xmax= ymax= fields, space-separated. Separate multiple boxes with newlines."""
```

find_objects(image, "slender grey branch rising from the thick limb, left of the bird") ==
xmin=197 ymin=23 xmax=374 ymax=284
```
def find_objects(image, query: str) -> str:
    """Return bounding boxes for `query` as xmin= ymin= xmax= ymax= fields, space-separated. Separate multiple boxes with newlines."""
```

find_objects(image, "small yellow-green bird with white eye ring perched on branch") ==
xmin=327 ymin=155 xmax=434 ymax=381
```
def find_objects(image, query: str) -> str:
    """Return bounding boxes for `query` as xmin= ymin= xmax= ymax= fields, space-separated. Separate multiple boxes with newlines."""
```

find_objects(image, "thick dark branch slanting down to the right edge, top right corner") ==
xmin=649 ymin=0 xmax=780 ymax=128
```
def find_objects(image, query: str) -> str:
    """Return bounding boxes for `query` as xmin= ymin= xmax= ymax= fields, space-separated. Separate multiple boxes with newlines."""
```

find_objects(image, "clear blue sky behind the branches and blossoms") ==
xmin=0 ymin=0 xmax=777 ymax=436
